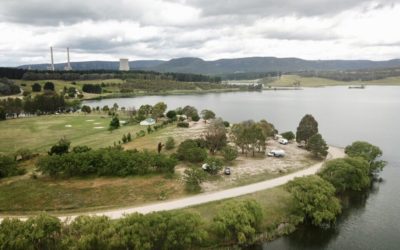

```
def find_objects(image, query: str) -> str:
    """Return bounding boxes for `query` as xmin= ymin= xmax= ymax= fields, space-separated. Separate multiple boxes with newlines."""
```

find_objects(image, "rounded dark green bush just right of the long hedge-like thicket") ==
xmin=177 ymin=139 xmax=207 ymax=162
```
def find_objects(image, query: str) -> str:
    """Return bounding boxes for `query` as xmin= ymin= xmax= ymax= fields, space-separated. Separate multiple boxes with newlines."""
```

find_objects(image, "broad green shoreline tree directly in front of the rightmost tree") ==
xmin=318 ymin=157 xmax=371 ymax=192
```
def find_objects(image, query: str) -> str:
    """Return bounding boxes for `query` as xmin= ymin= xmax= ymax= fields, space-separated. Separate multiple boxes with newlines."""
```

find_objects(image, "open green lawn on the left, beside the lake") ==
xmin=0 ymin=114 xmax=144 ymax=153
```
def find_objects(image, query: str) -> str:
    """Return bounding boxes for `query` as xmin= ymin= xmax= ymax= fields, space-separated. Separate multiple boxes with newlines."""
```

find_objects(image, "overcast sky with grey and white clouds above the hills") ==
xmin=0 ymin=0 xmax=400 ymax=66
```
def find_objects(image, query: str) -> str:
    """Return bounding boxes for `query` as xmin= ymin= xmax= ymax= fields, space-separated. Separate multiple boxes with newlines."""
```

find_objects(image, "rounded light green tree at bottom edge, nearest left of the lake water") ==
xmin=212 ymin=200 xmax=263 ymax=246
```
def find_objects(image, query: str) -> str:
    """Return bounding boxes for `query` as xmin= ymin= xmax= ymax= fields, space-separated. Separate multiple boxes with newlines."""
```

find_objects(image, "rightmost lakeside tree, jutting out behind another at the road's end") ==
xmin=344 ymin=141 xmax=386 ymax=175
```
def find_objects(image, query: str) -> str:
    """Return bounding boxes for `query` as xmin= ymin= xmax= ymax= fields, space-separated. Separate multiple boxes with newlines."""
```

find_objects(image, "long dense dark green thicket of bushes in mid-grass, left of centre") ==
xmin=37 ymin=147 xmax=177 ymax=177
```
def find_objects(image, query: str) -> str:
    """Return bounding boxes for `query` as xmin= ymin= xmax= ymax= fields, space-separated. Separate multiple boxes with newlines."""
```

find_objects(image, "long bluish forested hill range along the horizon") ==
xmin=20 ymin=57 xmax=400 ymax=75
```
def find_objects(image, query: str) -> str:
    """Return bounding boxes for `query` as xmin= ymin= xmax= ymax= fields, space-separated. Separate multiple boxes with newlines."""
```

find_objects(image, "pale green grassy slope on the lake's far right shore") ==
xmin=265 ymin=75 xmax=400 ymax=87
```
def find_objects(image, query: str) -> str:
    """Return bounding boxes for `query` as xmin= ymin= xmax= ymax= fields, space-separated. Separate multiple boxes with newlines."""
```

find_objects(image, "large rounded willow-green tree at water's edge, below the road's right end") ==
xmin=286 ymin=175 xmax=341 ymax=226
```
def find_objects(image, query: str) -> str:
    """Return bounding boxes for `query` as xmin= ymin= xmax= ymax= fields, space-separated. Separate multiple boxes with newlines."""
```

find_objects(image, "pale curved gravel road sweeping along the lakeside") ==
xmin=0 ymin=146 xmax=345 ymax=221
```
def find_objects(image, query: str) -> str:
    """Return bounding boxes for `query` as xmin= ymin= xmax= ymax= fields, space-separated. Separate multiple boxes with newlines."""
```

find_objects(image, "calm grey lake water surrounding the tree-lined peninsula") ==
xmin=85 ymin=86 xmax=400 ymax=250
